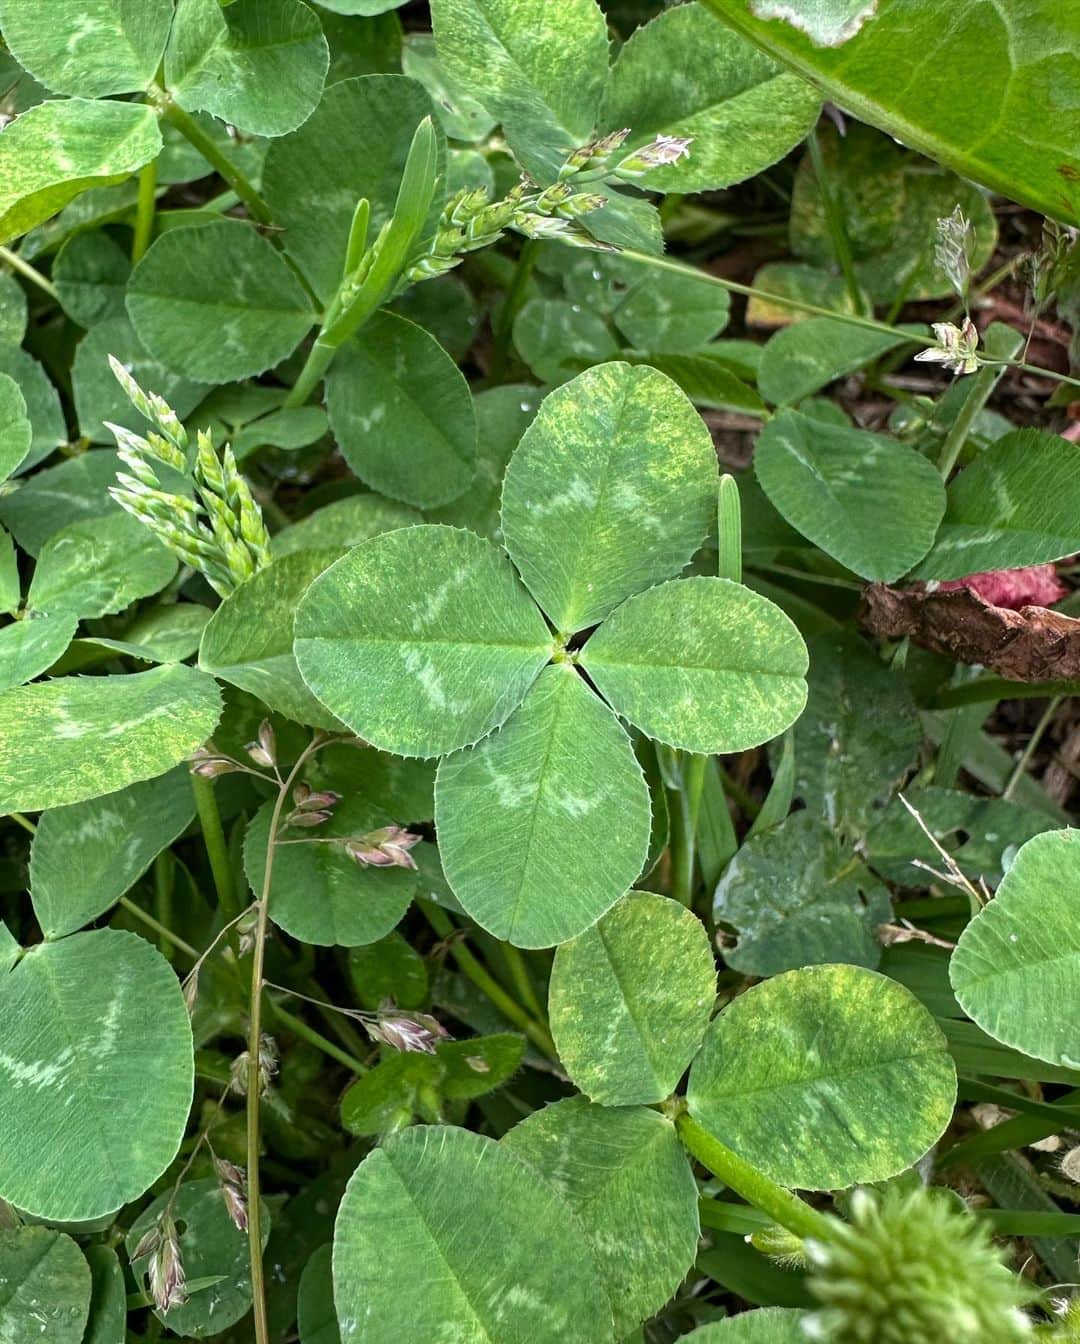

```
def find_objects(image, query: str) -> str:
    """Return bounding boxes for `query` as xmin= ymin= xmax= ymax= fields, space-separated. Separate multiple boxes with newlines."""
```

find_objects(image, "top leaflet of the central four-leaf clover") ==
xmin=502 ymin=363 xmax=717 ymax=633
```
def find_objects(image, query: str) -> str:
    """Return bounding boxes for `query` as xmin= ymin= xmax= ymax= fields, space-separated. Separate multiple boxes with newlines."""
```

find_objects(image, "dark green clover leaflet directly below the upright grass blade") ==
xmin=326 ymin=313 xmax=477 ymax=508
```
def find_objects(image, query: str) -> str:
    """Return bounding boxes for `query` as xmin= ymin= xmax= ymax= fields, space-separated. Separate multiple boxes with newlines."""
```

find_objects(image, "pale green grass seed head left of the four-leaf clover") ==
xmin=106 ymin=356 xmax=270 ymax=597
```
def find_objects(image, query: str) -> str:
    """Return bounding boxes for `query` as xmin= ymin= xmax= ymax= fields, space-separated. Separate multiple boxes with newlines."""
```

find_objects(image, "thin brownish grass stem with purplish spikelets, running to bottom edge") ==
xmin=245 ymin=737 xmax=328 ymax=1344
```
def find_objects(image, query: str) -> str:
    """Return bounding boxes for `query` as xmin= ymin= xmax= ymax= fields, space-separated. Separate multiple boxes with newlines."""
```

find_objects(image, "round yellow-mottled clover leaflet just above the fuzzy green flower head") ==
xmin=686 ymin=966 xmax=956 ymax=1189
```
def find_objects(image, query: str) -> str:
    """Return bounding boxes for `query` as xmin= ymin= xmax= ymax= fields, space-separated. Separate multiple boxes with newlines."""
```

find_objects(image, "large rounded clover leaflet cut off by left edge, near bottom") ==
xmin=0 ymin=929 xmax=193 ymax=1222
